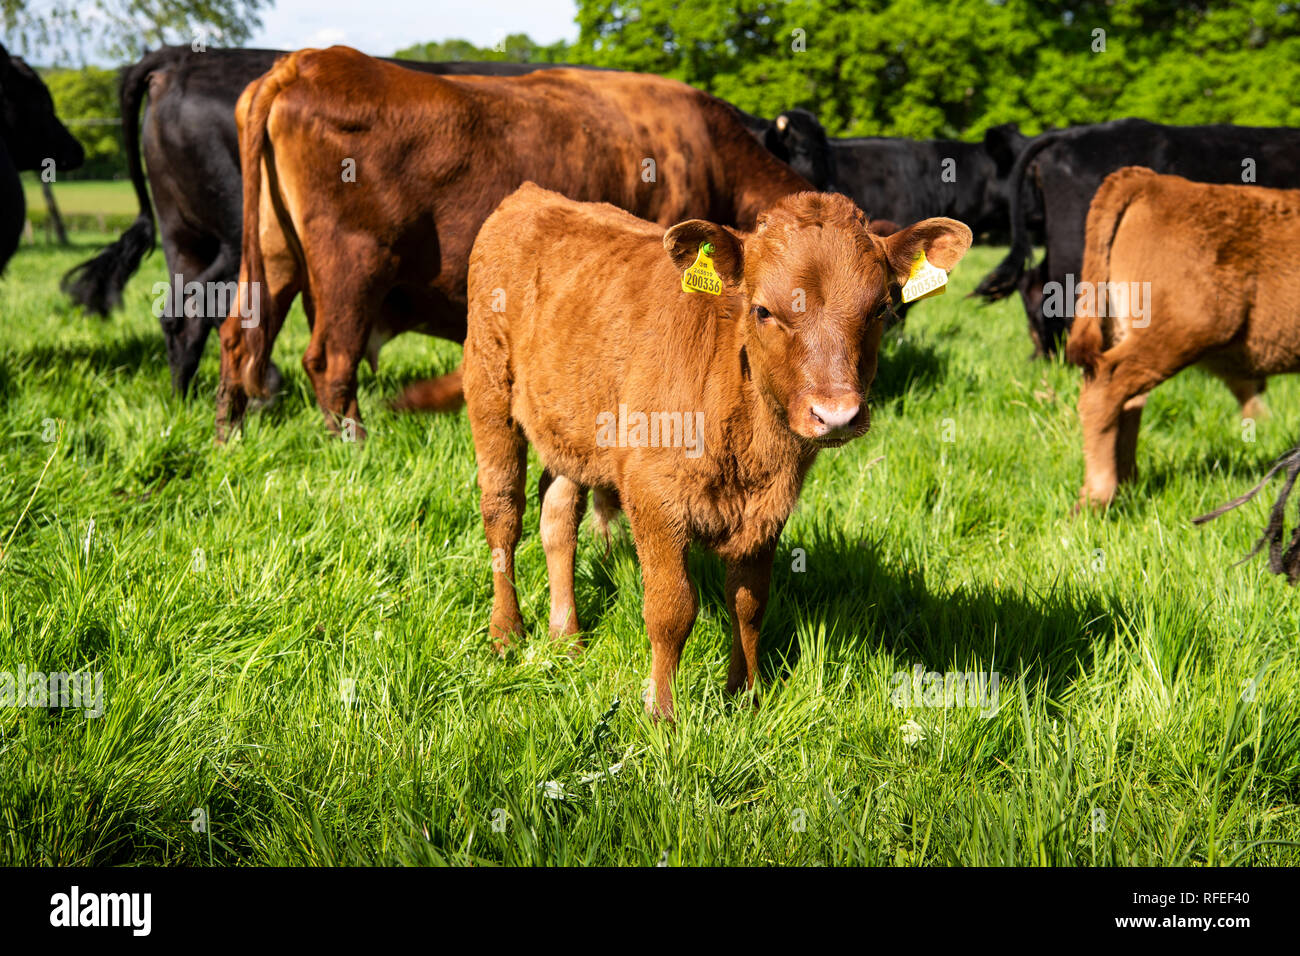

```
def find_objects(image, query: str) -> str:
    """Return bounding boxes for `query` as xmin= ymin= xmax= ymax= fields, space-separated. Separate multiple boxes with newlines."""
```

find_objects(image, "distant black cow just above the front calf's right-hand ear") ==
xmin=831 ymin=122 xmax=1030 ymax=242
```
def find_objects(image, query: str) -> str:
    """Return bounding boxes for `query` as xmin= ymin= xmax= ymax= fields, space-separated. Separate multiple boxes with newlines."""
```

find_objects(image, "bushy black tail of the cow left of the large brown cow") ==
xmin=59 ymin=48 xmax=172 ymax=316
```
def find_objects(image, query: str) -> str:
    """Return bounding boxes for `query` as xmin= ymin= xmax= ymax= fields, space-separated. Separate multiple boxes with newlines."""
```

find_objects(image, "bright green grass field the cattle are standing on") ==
xmin=0 ymin=231 xmax=1300 ymax=866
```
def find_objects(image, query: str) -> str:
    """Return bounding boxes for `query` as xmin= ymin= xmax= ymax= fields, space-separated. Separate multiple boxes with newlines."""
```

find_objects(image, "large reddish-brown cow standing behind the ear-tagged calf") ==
xmin=217 ymin=47 xmax=809 ymax=440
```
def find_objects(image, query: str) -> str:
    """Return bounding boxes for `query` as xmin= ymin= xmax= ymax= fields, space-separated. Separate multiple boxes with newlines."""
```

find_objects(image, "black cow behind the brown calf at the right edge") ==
xmin=974 ymin=120 xmax=1300 ymax=356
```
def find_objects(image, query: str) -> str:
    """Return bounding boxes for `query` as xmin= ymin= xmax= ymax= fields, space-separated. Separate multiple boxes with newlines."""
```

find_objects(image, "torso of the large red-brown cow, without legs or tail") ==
xmin=261 ymin=47 xmax=806 ymax=312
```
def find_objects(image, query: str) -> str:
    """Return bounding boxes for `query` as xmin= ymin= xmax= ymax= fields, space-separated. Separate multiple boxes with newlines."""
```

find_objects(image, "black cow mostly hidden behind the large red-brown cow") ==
xmin=62 ymin=47 xmax=824 ymax=395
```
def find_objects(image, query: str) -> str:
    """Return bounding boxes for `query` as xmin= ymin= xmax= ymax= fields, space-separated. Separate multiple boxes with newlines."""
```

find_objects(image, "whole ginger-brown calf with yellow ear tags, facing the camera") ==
xmin=464 ymin=183 xmax=971 ymax=717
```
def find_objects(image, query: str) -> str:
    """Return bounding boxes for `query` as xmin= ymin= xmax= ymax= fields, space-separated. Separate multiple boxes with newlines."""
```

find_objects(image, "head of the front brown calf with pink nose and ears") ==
xmin=663 ymin=193 xmax=971 ymax=446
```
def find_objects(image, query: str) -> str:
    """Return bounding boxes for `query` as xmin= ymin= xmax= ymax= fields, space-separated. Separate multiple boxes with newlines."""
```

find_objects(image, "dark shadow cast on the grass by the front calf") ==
xmin=566 ymin=515 xmax=1107 ymax=700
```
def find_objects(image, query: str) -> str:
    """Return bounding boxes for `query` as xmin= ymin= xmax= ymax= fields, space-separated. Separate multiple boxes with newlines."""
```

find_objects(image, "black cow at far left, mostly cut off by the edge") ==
xmin=0 ymin=46 xmax=86 ymax=273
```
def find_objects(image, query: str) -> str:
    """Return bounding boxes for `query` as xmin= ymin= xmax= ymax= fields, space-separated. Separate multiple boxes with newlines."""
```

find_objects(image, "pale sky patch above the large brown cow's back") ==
xmin=248 ymin=0 xmax=577 ymax=56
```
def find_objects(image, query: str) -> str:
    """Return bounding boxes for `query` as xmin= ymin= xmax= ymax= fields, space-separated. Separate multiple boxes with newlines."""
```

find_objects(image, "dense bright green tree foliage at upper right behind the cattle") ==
xmin=567 ymin=0 xmax=1300 ymax=137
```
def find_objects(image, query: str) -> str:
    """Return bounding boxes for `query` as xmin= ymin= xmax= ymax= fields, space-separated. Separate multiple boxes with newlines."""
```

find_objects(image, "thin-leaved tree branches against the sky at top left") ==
xmin=0 ymin=0 xmax=272 ymax=60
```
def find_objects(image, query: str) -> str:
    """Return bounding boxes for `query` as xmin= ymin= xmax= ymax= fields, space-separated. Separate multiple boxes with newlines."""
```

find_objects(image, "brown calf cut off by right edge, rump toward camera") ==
xmin=1066 ymin=166 xmax=1300 ymax=505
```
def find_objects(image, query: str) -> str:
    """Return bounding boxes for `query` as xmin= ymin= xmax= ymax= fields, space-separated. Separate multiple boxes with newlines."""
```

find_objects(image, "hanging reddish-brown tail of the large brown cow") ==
xmin=238 ymin=55 xmax=298 ymax=398
